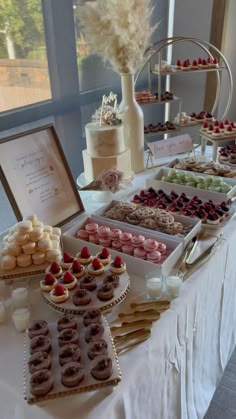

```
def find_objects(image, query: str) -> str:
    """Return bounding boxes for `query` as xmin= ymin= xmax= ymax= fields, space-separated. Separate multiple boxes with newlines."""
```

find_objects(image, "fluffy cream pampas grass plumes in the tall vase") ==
xmin=79 ymin=0 xmax=157 ymax=74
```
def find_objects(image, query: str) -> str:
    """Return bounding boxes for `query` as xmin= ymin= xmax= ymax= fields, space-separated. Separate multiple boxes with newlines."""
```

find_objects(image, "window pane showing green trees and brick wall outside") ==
xmin=0 ymin=0 xmax=51 ymax=112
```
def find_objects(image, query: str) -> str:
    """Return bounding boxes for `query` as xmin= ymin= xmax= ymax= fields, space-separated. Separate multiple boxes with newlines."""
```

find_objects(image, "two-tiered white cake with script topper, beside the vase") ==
xmin=82 ymin=93 xmax=131 ymax=182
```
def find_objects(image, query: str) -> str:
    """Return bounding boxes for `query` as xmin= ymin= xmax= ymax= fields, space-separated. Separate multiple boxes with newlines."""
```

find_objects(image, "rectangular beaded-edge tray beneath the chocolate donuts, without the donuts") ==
xmin=24 ymin=316 xmax=121 ymax=404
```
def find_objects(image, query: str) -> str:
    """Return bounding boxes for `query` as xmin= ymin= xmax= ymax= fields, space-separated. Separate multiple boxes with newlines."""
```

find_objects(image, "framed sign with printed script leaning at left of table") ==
xmin=0 ymin=125 xmax=84 ymax=226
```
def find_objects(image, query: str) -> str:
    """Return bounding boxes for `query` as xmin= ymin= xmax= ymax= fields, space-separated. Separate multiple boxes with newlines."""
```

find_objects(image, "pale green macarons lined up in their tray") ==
xmin=161 ymin=169 xmax=232 ymax=194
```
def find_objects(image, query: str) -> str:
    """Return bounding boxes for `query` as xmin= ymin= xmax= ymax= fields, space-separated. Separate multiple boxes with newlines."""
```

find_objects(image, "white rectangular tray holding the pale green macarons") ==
xmin=146 ymin=167 xmax=236 ymax=203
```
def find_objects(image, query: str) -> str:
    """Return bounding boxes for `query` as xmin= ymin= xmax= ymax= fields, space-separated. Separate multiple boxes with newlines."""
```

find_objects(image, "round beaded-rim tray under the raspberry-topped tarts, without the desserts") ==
xmin=42 ymin=267 xmax=130 ymax=314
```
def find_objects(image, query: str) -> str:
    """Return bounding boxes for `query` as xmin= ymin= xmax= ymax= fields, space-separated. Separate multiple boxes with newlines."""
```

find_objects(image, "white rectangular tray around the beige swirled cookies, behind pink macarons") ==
xmin=92 ymin=201 xmax=202 ymax=247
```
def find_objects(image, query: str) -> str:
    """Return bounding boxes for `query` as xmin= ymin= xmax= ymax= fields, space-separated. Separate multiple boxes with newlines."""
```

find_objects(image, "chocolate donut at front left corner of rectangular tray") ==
xmin=30 ymin=370 xmax=53 ymax=396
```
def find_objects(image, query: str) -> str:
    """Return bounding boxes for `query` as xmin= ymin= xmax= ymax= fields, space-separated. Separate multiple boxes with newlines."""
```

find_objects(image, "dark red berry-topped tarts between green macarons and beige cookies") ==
xmin=133 ymin=187 xmax=230 ymax=226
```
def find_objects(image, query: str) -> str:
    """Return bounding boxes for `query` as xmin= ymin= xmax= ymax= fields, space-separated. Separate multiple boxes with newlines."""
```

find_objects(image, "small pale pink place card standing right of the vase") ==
xmin=147 ymin=134 xmax=193 ymax=159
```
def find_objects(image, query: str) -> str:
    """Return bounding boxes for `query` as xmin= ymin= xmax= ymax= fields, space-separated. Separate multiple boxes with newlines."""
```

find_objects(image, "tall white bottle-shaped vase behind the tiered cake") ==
xmin=120 ymin=73 xmax=144 ymax=173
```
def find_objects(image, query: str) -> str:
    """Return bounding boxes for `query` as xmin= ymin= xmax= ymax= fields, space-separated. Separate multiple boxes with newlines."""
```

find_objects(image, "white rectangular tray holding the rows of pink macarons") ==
xmin=62 ymin=216 xmax=183 ymax=277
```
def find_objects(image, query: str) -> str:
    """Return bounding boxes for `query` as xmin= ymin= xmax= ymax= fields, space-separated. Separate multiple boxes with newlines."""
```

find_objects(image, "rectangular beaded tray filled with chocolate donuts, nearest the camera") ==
xmin=24 ymin=316 xmax=121 ymax=403
